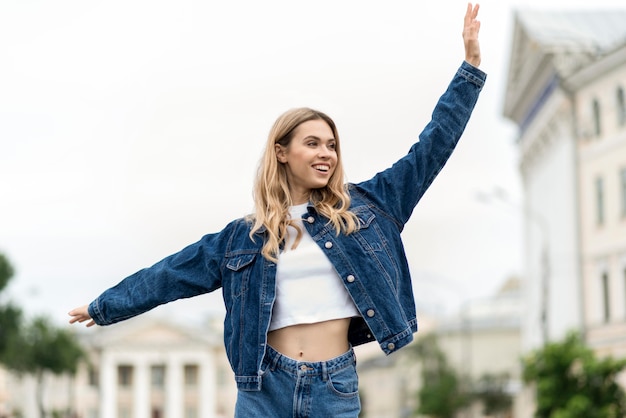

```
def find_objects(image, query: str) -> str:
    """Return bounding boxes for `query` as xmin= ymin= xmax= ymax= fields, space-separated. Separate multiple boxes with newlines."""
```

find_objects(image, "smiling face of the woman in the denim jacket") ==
xmin=276 ymin=119 xmax=337 ymax=205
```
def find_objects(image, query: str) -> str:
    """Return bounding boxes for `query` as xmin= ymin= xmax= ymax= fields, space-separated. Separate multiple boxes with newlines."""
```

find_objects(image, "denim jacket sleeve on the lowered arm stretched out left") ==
xmin=88 ymin=231 xmax=224 ymax=325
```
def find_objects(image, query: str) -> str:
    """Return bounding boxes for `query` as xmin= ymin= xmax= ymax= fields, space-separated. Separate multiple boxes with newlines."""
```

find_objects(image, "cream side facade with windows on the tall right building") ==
xmin=567 ymin=40 xmax=626 ymax=364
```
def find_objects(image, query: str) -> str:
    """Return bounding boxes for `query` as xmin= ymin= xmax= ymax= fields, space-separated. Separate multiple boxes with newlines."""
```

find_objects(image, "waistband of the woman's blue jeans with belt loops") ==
xmin=265 ymin=345 xmax=356 ymax=380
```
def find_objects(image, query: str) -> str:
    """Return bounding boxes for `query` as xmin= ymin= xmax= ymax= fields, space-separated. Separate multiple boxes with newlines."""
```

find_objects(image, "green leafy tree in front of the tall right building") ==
xmin=522 ymin=332 xmax=626 ymax=418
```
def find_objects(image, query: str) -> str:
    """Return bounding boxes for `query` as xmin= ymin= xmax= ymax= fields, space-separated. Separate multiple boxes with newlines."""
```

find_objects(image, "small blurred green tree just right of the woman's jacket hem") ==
xmin=414 ymin=334 xmax=470 ymax=418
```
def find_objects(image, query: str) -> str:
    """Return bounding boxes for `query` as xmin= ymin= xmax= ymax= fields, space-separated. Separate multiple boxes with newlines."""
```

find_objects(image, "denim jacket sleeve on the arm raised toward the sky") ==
xmin=355 ymin=62 xmax=487 ymax=230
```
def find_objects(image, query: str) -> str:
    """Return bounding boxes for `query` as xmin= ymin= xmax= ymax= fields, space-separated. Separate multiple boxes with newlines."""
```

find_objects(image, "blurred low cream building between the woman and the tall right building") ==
xmin=357 ymin=278 xmax=522 ymax=418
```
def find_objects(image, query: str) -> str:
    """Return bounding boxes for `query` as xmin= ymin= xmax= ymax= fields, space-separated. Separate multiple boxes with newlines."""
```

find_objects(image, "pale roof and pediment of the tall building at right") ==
xmin=503 ymin=8 xmax=626 ymax=125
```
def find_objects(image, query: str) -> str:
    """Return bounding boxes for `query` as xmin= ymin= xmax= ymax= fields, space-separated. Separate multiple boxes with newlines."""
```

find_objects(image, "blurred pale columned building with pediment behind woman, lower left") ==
xmin=1 ymin=313 xmax=236 ymax=418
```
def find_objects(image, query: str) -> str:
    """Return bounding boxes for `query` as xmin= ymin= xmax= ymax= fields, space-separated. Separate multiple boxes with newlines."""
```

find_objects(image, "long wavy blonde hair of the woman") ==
xmin=250 ymin=108 xmax=358 ymax=262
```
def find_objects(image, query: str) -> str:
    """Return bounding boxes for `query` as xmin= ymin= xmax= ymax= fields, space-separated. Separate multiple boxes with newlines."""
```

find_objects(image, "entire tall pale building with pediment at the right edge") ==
xmin=503 ymin=9 xmax=626 ymax=356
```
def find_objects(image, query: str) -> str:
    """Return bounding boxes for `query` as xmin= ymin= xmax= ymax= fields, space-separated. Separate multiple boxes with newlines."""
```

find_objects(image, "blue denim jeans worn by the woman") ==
xmin=235 ymin=346 xmax=361 ymax=418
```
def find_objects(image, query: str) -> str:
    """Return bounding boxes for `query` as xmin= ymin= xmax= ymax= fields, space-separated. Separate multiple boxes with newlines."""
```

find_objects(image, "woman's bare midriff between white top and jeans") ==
xmin=267 ymin=318 xmax=350 ymax=361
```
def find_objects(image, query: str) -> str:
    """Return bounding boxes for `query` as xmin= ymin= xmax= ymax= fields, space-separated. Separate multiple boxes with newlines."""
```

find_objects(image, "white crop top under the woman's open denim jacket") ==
xmin=269 ymin=204 xmax=360 ymax=331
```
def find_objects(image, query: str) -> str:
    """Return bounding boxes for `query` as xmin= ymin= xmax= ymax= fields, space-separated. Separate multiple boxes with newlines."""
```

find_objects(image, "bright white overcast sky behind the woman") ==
xmin=0 ymin=0 xmax=623 ymax=322
